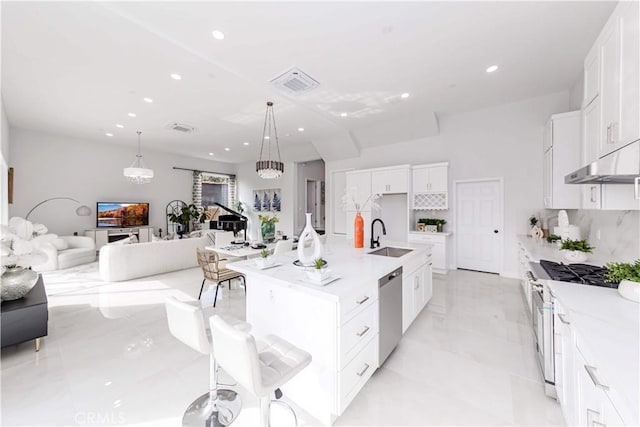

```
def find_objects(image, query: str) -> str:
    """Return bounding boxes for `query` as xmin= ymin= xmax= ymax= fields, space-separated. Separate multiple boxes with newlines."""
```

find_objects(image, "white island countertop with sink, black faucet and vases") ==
xmin=227 ymin=239 xmax=432 ymax=301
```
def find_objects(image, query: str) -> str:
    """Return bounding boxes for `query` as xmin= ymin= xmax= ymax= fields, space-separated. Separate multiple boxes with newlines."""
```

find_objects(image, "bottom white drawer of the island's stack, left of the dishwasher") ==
xmin=338 ymin=334 xmax=378 ymax=414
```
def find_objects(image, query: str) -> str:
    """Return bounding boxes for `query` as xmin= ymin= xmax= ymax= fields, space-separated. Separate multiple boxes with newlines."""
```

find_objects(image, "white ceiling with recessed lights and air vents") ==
xmin=2 ymin=1 xmax=615 ymax=162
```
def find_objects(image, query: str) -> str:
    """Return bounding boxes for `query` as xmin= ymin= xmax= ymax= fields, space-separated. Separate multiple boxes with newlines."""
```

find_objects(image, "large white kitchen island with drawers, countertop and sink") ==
xmin=228 ymin=238 xmax=431 ymax=425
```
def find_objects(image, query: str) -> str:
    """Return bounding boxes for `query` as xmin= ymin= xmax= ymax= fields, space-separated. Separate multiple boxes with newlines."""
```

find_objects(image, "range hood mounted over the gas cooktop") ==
xmin=564 ymin=139 xmax=640 ymax=184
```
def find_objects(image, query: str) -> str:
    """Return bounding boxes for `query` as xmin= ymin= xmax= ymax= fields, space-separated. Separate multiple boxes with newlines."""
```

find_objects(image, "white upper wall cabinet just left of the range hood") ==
xmin=543 ymin=111 xmax=582 ymax=209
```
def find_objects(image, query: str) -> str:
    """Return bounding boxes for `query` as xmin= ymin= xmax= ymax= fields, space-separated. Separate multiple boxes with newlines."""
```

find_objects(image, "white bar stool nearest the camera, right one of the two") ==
xmin=209 ymin=315 xmax=311 ymax=427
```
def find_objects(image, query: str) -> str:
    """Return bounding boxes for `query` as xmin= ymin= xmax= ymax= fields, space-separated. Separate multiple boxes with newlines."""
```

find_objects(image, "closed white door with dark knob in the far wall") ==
xmin=455 ymin=179 xmax=503 ymax=273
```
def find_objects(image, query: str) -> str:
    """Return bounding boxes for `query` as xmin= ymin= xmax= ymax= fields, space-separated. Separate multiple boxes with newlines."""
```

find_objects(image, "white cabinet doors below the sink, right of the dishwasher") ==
xmin=402 ymin=258 xmax=433 ymax=333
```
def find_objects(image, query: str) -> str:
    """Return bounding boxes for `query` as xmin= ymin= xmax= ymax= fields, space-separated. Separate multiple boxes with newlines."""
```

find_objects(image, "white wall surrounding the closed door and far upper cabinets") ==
xmin=326 ymin=91 xmax=569 ymax=276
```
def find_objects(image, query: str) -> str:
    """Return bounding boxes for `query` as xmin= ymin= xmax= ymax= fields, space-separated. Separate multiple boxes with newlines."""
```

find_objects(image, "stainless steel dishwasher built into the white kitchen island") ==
xmin=378 ymin=267 xmax=402 ymax=366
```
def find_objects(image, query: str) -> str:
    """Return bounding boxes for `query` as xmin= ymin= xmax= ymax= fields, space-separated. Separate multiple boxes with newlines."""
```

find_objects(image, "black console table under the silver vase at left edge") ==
xmin=0 ymin=275 xmax=49 ymax=351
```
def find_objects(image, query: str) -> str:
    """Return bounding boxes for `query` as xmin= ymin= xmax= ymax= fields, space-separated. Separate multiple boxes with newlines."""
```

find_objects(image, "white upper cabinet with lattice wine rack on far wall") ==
xmin=412 ymin=162 xmax=449 ymax=209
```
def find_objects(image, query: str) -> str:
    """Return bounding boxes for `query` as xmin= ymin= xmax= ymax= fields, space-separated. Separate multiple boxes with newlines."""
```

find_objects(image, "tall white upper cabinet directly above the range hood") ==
xmin=596 ymin=2 xmax=640 ymax=156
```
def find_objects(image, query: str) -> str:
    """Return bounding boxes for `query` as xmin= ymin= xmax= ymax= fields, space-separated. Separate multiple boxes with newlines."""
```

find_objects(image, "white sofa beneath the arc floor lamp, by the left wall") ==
xmin=33 ymin=236 xmax=96 ymax=271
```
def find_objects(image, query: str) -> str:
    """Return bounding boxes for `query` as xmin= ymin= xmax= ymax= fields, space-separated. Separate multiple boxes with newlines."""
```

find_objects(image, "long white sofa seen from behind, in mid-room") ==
xmin=99 ymin=237 xmax=210 ymax=282
